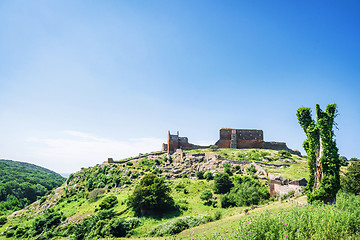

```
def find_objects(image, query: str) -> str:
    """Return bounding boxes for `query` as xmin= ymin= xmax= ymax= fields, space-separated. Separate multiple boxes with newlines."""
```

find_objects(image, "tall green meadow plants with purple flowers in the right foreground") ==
xmin=208 ymin=193 xmax=360 ymax=240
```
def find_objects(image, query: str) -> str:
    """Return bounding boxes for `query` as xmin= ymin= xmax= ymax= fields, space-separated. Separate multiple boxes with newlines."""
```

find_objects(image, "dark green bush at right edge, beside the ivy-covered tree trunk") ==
xmin=341 ymin=162 xmax=360 ymax=195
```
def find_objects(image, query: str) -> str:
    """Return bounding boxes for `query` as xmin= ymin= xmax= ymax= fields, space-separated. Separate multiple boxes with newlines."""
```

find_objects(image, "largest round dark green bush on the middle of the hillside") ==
xmin=128 ymin=173 xmax=174 ymax=214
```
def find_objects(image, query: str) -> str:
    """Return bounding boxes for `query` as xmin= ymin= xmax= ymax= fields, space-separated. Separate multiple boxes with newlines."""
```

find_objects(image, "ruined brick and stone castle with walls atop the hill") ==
xmin=162 ymin=128 xmax=301 ymax=156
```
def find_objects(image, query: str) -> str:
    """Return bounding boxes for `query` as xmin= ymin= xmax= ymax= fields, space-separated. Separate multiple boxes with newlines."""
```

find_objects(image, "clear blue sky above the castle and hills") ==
xmin=0 ymin=0 xmax=360 ymax=172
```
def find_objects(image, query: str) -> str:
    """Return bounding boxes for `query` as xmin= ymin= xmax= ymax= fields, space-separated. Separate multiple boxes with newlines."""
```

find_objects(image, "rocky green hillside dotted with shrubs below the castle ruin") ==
xmin=0 ymin=149 xmax=307 ymax=239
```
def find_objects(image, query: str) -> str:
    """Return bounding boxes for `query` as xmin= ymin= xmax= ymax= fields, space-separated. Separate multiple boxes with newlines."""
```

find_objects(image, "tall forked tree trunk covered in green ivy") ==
xmin=296 ymin=104 xmax=340 ymax=204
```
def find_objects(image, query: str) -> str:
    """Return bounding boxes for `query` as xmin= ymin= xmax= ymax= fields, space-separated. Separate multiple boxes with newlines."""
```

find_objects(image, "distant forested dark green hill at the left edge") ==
xmin=0 ymin=159 xmax=65 ymax=215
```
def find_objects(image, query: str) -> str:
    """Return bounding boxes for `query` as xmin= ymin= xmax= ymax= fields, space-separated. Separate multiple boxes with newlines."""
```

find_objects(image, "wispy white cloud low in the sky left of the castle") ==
xmin=29 ymin=131 xmax=163 ymax=173
